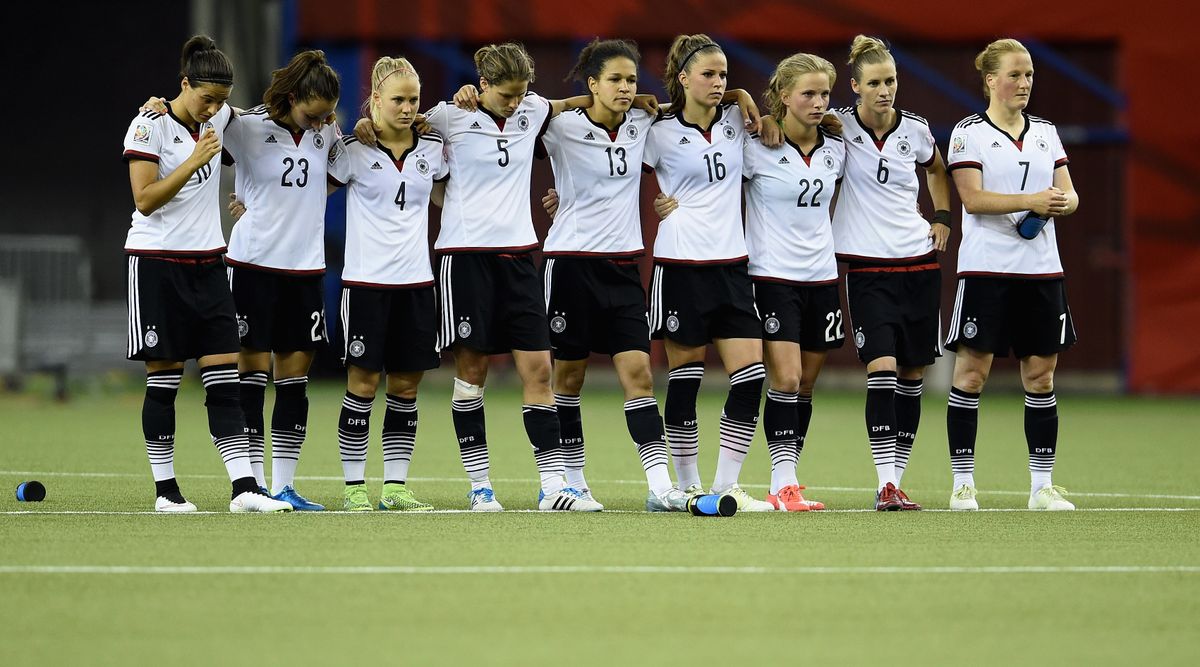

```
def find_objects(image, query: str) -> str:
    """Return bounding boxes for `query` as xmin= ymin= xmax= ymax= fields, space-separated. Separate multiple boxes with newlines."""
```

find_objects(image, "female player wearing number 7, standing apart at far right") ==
xmin=946 ymin=40 xmax=1079 ymax=510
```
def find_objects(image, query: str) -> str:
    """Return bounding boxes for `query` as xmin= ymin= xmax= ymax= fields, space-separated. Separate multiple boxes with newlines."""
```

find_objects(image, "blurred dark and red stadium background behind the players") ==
xmin=0 ymin=0 xmax=1200 ymax=393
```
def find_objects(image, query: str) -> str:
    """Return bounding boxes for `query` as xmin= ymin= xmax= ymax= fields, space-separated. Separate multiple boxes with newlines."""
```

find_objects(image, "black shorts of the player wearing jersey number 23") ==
xmin=229 ymin=265 xmax=329 ymax=351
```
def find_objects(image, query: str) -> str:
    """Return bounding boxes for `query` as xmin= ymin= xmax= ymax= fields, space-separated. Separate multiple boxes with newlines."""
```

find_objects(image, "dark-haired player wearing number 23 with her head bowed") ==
xmin=218 ymin=50 xmax=340 ymax=510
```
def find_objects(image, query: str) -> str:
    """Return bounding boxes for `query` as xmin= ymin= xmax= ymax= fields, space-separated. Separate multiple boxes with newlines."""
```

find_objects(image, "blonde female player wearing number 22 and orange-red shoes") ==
xmin=743 ymin=53 xmax=846 ymax=512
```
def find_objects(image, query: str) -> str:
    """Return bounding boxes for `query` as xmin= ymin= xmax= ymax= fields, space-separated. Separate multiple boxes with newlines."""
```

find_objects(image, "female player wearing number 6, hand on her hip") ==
xmin=833 ymin=35 xmax=950 ymax=510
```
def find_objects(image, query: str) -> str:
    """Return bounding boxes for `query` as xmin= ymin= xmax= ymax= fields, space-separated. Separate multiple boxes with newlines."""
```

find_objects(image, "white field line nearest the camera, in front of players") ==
xmin=0 ymin=565 xmax=1200 ymax=575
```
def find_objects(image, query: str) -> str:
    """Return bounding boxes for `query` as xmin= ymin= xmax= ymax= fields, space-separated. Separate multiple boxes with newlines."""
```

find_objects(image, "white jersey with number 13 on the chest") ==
xmin=541 ymin=109 xmax=654 ymax=257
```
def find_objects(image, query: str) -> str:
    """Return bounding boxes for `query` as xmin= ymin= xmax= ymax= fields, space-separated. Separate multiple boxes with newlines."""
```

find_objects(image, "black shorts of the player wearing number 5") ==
xmin=438 ymin=252 xmax=550 ymax=354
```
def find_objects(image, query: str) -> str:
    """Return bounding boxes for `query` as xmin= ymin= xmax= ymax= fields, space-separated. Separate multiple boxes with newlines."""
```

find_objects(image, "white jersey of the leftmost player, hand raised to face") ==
xmin=124 ymin=104 xmax=233 ymax=256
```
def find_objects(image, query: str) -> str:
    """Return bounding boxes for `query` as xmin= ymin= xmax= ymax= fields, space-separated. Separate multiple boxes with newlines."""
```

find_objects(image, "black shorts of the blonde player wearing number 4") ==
xmin=338 ymin=286 xmax=442 ymax=373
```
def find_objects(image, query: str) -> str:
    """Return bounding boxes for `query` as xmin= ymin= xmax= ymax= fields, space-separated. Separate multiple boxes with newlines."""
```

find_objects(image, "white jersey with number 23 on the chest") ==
xmin=226 ymin=106 xmax=342 ymax=274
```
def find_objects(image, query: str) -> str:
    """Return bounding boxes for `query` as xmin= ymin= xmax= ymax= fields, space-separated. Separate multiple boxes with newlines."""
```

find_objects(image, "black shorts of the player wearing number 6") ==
xmin=846 ymin=269 xmax=942 ymax=366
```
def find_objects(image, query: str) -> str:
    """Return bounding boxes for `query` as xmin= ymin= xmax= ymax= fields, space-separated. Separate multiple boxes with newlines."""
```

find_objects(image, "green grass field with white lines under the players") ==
xmin=0 ymin=372 xmax=1200 ymax=666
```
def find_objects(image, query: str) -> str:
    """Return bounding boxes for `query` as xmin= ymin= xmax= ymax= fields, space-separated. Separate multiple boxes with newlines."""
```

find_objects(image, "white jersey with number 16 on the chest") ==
xmin=642 ymin=104 xmax=746 ymax=264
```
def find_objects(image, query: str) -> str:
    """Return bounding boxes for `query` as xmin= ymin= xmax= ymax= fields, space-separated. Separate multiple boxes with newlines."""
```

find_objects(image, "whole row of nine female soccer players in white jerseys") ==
xmin=125 ymin=35 xmax=1079 ymax=511
